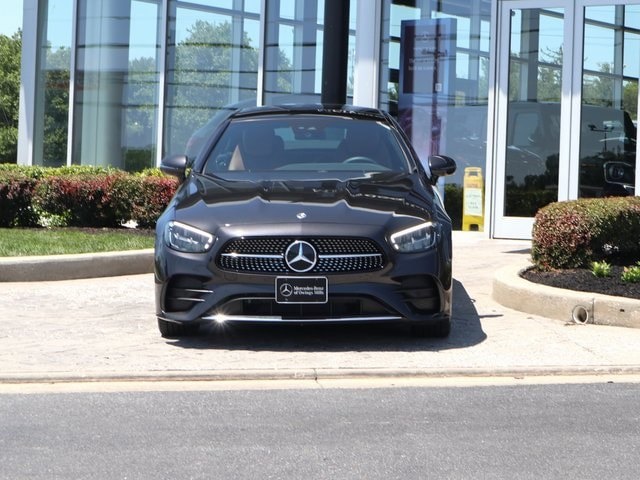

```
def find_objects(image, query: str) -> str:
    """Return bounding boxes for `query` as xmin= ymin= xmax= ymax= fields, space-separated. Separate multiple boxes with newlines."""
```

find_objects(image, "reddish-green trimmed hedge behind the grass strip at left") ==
xmin=0 ymin=165 xmax=178 ymax=228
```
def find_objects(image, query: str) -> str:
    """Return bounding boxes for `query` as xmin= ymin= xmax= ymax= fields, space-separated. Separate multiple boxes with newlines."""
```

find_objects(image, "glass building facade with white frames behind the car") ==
xmin=18 ymin=0 xmax=640 ymax=238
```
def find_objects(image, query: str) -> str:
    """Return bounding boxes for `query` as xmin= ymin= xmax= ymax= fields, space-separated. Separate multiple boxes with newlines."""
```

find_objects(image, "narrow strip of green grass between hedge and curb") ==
xmin=0 ymin=228 xmax=153 ymax=257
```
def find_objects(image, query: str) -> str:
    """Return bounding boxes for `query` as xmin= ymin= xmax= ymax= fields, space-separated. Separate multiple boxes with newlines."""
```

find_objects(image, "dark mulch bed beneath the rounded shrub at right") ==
xmin=522 ymin=266 xmax=640 ymax=299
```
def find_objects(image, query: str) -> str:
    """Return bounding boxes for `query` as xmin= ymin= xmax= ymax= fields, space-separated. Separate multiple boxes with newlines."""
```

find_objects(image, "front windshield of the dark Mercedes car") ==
xmin=203 ymin=115 xmax=409 ymax=177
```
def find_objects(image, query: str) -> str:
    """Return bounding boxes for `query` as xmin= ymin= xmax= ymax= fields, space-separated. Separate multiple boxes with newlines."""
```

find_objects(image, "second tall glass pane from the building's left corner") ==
xmin=72 ymin=0 xmax=160 ymax=171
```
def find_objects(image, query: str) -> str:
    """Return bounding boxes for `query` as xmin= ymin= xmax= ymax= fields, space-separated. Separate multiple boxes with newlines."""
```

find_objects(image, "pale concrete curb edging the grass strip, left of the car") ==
xmin=0 ymin=249 xmax=153 ymax=282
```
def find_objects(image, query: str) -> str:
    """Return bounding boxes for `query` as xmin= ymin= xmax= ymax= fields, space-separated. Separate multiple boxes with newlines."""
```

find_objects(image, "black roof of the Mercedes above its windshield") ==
xmin=230 ymin=103 xmax=387 ymax=120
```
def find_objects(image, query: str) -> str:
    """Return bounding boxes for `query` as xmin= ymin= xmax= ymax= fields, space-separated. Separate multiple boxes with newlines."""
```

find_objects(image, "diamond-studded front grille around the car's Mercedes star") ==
xmin=217 ymin=237 xmax=384 ymax=274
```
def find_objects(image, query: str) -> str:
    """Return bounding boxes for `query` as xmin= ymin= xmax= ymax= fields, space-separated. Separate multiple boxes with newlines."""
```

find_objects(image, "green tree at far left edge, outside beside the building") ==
xmin=0 ymin=30 xmax=22 ymax=163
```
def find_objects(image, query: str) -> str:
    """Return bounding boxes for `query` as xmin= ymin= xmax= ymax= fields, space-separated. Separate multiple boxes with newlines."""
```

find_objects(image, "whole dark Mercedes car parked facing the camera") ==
xmin=155 ymin=105 xmax=456 ymax=337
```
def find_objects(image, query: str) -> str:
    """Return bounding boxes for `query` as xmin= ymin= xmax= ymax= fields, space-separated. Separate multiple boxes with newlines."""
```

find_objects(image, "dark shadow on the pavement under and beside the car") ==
xmin=167 ymin=280 xmax=486 ymax=352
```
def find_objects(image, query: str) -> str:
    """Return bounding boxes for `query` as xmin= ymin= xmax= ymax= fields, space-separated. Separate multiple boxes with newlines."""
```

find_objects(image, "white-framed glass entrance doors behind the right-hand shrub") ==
xmin=492 ymin=0 xmax=640 ymax=238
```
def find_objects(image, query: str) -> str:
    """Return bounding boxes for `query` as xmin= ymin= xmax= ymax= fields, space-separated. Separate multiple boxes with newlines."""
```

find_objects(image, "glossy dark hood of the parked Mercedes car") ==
xmin=173 ymin=173 xmax=434 ymax=231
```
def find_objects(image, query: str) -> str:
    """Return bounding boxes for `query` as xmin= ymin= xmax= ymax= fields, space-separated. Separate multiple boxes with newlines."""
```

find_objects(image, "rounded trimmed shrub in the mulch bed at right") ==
xmin=531 ymin=197 xmax=640 ymax=269
